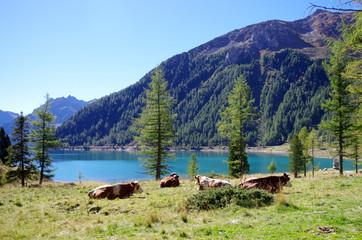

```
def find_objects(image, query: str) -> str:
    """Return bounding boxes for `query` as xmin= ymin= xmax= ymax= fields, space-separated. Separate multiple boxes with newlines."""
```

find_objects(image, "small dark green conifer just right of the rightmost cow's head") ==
xmin=288 ymin=135 xmax=304 ymax=178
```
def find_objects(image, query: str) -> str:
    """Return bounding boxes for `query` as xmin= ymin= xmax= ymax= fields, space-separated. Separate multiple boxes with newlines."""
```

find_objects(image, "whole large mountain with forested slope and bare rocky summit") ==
xmin=57 ymin=10 xmax=353 ymax=147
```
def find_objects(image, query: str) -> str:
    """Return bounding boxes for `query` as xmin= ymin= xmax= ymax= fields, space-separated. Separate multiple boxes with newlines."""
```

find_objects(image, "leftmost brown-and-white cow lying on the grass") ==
xmin=88 ymin=181 xmax=143 ymax=200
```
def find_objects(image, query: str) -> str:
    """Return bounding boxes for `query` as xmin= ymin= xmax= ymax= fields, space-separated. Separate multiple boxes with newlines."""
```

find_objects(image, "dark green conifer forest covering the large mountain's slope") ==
xmin=58 ymin=50 xmax=329 ymax=147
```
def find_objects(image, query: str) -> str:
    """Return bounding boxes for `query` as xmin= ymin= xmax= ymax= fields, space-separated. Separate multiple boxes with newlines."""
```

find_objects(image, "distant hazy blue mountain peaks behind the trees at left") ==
xmin=0 ymin=96 xmax=94 ymax=135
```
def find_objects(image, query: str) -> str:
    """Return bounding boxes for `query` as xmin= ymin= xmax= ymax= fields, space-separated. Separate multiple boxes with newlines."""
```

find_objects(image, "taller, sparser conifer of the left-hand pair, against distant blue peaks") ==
xmin=30 ymin=94 xmax=60 ymax=185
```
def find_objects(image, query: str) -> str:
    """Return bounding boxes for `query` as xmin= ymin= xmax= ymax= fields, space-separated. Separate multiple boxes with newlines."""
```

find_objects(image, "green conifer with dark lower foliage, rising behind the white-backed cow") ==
xmin=217 ymin=75 xmax=257 ymax=178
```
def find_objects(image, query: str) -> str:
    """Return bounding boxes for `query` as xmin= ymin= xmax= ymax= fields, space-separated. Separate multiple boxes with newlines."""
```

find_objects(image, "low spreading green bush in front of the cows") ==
xmin=186 ymin=187 xmax=274 ymax=210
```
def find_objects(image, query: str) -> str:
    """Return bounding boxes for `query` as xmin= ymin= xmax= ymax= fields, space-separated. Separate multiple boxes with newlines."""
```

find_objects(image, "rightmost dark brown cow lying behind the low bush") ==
xmin=237 ymin=173 xmax=292 ymax=193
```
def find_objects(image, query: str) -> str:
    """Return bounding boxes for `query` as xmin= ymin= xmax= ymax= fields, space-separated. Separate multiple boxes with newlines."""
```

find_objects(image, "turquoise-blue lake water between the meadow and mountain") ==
xmin=51 ymin=151 xmax=354 ymax=183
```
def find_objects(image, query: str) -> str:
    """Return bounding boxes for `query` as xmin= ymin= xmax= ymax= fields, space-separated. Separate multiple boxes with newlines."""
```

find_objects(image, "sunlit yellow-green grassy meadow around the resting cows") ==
xmin=0 ymin=170 xmax=362 ymax=239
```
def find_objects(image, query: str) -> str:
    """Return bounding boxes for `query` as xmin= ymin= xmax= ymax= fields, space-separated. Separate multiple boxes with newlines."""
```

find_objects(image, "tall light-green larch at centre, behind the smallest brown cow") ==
xmin=133 ymin=68 xmax=176 ymax=180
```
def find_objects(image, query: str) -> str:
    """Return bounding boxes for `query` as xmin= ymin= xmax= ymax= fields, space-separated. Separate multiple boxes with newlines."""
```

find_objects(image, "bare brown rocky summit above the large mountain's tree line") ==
xmin=191 ymin=10 xmax=353 ymax=64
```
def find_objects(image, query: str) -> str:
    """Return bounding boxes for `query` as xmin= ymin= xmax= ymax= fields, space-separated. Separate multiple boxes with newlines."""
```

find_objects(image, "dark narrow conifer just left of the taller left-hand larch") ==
xmin=6 ymin=113 xmax=35 ymax=187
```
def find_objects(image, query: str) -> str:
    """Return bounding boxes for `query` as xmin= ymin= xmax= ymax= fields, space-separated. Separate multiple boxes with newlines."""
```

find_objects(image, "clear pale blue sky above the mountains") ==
xmin=0 ymin=0 xmax=356 ymax=114
